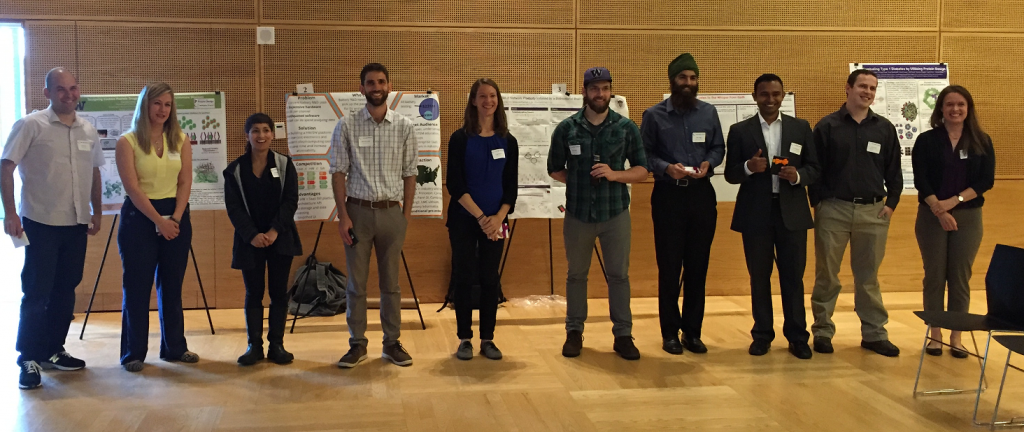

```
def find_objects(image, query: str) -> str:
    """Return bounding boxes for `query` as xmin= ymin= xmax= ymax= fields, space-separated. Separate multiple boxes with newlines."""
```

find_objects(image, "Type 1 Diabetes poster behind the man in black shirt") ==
xmin=850 ymin=63 xmax=949 ymax=193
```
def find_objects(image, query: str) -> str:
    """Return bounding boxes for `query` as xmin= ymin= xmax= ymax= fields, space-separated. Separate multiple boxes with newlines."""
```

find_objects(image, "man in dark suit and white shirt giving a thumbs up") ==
xmin=725 ymin=74 xmax=820 ymax=359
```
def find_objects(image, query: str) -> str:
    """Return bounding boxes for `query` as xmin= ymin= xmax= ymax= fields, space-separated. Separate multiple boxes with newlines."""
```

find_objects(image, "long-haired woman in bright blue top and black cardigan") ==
xmin=444 ymin=78 xmax=519 ymax=360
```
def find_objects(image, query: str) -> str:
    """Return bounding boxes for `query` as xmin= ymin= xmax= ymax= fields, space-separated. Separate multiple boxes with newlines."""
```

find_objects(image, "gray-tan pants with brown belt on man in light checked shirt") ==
xmin=345 ymin=203 xmax=409 ymax=347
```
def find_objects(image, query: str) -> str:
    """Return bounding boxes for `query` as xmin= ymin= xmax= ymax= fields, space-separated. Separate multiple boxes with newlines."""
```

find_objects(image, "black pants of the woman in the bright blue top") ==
xmin=447 ymin=211 xmax=505 ymax=340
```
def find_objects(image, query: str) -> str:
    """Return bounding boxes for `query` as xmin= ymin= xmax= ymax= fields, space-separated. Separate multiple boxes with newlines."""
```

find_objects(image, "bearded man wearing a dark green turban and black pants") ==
xmin=641 ymin=53 xmax=725 ymax=354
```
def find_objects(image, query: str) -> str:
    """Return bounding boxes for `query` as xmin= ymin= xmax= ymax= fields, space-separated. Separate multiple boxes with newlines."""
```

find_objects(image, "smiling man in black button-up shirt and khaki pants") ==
xmin=809 ymin=70 xmax=903 ymax=357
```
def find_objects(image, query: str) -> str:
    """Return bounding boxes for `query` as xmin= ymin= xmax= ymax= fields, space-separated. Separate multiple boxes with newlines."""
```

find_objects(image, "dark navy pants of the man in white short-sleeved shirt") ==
xmin=15 ymin=215 xmax=88 ymax=363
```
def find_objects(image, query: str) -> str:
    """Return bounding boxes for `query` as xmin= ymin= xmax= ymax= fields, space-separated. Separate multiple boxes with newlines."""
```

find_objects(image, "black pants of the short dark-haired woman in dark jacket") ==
xmin=242 ymin=246 xmax=295 ymax=347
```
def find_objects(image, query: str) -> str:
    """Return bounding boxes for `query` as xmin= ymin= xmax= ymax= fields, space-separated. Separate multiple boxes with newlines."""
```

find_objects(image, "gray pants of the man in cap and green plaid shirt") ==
xmin=562 ymin=210 xmax=633 ymax=337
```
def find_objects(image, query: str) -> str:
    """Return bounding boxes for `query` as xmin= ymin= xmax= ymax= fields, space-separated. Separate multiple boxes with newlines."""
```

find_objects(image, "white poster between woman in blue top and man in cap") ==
xmin=502 ymin=93 xmax=630 ymax=219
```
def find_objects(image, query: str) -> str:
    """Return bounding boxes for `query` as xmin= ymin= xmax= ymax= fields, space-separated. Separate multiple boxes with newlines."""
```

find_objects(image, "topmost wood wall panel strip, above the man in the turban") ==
xmin=578 ymin=0 xmax=939 ymax=30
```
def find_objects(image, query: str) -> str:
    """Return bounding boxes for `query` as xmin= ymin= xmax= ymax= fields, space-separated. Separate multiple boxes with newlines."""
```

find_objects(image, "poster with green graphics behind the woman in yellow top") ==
xmin=77 ymin=92 xmax=227 ymax=214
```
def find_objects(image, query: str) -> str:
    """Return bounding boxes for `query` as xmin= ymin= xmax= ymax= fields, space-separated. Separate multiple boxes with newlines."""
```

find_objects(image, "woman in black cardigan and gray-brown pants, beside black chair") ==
xmin=912 ymin=85 xmax=995 ymax=358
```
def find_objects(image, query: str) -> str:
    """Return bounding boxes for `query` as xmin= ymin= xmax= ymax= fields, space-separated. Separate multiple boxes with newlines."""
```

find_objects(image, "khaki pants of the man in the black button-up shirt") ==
xmin=811 ymin=200 xmax=889 ymax=342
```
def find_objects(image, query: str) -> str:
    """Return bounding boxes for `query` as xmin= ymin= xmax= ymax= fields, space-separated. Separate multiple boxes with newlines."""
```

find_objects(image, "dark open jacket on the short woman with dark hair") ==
xmin=223 ymin=150 xmax=302 ymax=270
